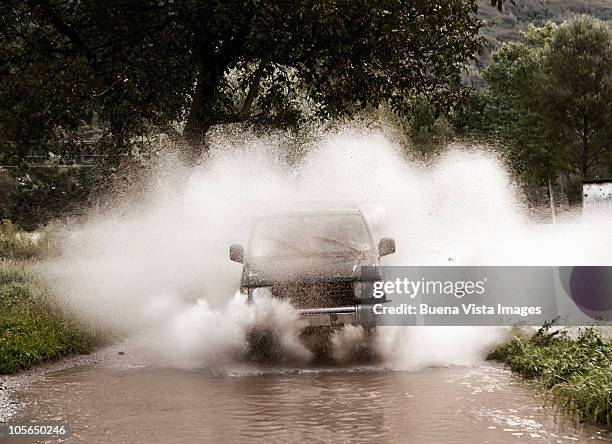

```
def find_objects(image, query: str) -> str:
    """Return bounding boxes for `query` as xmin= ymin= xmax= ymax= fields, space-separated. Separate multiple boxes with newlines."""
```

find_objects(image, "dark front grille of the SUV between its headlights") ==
xmin=272 ymin=282 xmax=357 ymax=309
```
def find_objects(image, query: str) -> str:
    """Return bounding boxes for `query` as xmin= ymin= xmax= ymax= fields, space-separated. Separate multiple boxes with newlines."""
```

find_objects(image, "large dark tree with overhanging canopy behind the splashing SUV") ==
xmin=0 ymin=0 xmax=480 ymax=161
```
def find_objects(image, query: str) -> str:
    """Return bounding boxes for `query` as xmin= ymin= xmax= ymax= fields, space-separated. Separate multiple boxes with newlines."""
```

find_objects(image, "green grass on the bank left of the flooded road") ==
xmin=0 ymin=260 xmax=102 ymax=374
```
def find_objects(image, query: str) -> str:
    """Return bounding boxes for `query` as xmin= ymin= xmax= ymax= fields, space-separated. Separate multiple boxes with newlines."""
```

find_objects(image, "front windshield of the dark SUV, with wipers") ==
xmin=249 ymin=214 xmax=372 ymax=257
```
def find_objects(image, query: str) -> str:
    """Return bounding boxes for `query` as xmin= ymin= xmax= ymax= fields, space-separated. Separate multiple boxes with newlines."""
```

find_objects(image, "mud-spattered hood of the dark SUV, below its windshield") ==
xmin=244 ymin=254 xmax=378 ymax=287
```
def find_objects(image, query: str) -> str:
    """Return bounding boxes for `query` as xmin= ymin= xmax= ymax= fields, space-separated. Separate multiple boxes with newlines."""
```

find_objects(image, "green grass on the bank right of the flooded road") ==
xmin=489 ymin=324 xmax=612 ymax=426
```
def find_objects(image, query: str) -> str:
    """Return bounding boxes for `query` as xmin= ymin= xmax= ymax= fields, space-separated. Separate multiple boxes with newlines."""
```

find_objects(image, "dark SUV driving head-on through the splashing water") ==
xmin=230 ymin=203 xmax=395 ymax=329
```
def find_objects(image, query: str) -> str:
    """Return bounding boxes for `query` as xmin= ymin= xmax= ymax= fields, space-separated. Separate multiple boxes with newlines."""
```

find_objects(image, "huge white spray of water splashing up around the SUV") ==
xmin=48 ymin=125 xmax=612 ymax=369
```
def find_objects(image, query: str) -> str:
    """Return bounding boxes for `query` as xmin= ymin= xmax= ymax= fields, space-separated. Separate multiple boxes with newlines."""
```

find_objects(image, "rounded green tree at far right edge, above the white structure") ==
xmin=543 ymin=16 xmax=612 ymax=180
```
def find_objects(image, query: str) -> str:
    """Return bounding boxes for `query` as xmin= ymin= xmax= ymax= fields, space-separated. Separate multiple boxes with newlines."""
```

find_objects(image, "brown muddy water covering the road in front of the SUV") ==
xmin=5 ymin=364 xmax=612 ymax=444
